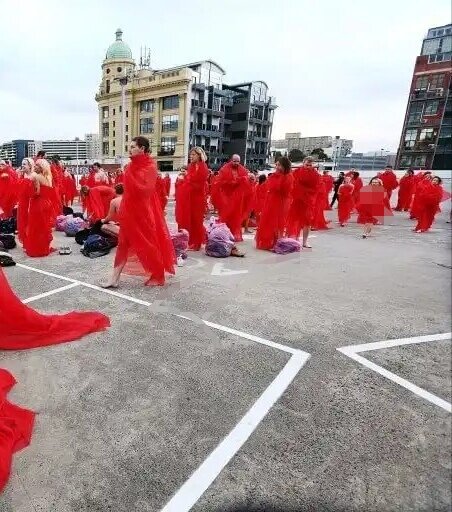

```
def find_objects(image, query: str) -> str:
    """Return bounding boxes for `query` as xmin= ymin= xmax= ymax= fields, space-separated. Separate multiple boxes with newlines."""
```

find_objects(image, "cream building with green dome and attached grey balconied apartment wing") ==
xmin=96 ymin=29 xmax=275 ymax=171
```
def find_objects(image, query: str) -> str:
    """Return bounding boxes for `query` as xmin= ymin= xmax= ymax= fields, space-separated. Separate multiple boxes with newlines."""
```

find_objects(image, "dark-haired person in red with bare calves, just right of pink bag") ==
xmin=287 ymin=156 xmax=320 ymax=249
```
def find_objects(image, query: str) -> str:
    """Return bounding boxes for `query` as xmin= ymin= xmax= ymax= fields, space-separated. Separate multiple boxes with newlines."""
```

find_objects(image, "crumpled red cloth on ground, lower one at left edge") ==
xmin=0 ymin=370 xmax=35 ymax=493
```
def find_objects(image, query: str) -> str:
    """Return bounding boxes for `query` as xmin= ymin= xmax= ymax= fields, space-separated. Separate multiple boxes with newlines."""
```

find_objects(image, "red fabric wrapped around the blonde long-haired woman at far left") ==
xmin=21 ymin=184 xmax=56 ymax=258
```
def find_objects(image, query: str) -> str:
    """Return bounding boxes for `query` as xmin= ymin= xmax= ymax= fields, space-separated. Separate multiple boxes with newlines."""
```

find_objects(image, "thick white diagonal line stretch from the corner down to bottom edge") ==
xmin=160 ymin=351 xmax=309 ymax=512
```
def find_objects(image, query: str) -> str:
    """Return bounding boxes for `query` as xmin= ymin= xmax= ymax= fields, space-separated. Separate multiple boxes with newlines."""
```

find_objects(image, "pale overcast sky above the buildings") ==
xmin=0 ymin=0 xmax=451 ymax=151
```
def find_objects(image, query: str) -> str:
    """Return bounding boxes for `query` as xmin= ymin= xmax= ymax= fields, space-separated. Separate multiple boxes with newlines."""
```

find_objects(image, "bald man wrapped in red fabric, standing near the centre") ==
xmin=218 ymin=155 xmax=251 ymax=242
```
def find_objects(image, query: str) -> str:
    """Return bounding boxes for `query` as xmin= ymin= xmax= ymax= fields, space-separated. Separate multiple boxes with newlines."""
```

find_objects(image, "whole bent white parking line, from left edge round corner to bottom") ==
xmin=17 ymin=264 xmax=311 ymax=512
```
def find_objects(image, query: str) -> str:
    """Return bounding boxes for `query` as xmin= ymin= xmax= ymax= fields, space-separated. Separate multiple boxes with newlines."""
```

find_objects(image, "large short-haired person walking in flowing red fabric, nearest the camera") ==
xmin=104 ymin=137 xmax=176 ymax=288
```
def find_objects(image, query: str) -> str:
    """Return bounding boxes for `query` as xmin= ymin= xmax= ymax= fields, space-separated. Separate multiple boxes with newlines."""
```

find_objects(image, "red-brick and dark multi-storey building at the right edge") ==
xmin=396 ymin=25 xmax=452 ymax=170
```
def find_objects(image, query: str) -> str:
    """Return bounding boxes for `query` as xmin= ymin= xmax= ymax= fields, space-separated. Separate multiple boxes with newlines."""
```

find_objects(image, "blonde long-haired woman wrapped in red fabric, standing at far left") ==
xmin=23 ymin=159 xmax=57 ymax=258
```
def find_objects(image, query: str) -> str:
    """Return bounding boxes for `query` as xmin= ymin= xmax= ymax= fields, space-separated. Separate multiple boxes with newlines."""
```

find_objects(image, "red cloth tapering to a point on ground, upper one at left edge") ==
xmin=0 ymin=268 xmax=110 ymax=350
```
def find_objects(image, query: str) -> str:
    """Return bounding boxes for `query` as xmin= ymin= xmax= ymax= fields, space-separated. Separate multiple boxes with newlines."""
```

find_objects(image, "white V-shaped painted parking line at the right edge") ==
xmin=337 ymin=332 xmax=452 ymax=412
